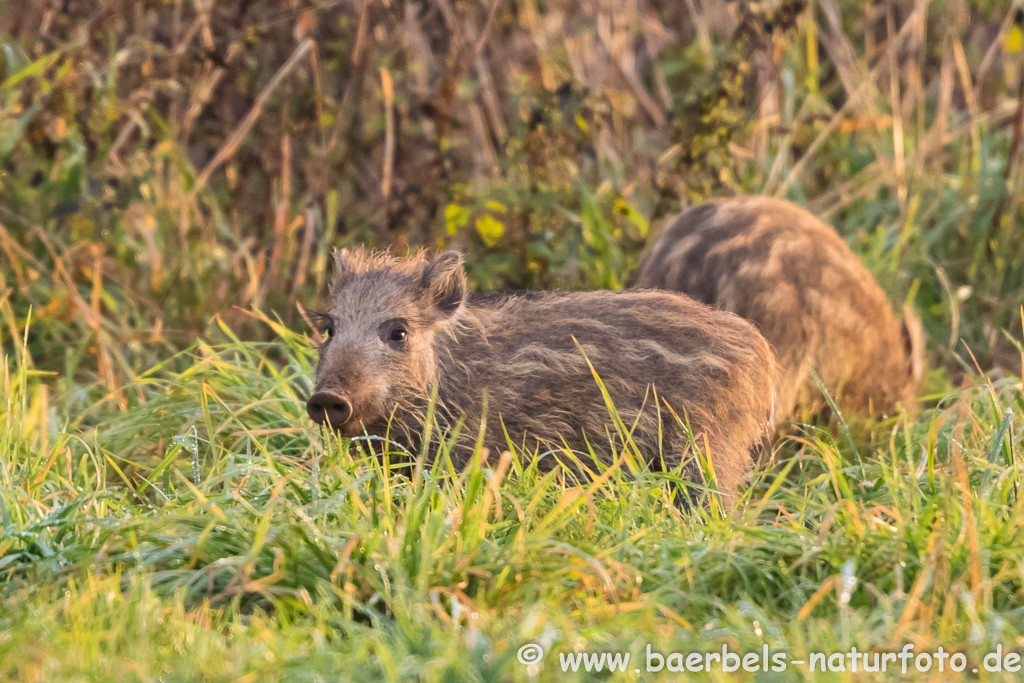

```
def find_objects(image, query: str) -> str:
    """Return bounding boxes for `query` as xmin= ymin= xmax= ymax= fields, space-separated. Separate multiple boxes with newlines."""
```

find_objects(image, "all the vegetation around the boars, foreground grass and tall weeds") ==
xmin=0 ymin=0 xmax=1024 ymax=681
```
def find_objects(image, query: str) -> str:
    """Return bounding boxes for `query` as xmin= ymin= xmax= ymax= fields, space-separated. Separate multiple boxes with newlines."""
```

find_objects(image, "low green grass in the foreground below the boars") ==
xmin=0 ymin=317 xmax=1024 ymax=681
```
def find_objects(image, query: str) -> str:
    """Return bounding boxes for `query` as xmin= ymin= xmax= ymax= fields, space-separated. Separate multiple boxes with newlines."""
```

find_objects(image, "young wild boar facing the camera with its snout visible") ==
xmin=307 ymin=250 xmax=774 ymax=505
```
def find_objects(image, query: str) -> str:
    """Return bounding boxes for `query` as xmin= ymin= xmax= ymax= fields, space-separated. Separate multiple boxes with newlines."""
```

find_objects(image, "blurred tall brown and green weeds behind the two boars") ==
xmin=0 ymin=0 xmax=1024 ymax=402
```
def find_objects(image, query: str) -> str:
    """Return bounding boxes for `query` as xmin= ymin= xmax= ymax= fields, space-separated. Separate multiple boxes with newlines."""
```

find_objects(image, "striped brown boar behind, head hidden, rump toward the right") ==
xmin=635 ymin=197 xmax=924 ymax=423
